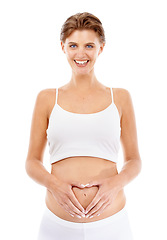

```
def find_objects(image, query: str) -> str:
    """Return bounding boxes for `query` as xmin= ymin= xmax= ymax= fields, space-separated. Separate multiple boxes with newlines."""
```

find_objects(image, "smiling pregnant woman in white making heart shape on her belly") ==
xmin=26 ymin=12 xmax=141 ymax=240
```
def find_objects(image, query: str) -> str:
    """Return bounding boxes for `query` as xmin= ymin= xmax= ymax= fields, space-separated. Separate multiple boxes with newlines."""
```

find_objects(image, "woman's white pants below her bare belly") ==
xmin=38 ymin=207 xmax=133 ymax=240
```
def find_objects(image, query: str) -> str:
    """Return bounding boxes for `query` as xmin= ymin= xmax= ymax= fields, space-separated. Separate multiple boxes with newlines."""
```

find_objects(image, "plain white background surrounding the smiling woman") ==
xmin=0 ymin=0 xmax=167 ymax=240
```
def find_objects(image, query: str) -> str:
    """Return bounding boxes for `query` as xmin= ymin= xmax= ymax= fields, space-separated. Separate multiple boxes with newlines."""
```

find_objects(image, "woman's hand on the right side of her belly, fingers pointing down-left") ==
xmin=83 ymin=176 xmax=120 ymax=217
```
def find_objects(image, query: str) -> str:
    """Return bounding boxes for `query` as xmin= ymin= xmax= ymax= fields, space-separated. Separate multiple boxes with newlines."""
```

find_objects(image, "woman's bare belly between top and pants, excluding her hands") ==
xmin=45 ymin=156 xmax=126 ymax=223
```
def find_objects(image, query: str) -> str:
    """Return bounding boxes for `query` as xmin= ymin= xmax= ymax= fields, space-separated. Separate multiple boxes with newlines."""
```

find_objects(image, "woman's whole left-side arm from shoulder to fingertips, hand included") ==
xmin=25 ymin=89 xmax=84 ymax=216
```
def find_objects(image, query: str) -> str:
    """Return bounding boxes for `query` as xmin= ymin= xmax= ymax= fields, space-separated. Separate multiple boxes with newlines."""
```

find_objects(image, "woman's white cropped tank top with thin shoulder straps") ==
xmin=46 ymin=88 xmax=121 ymax=164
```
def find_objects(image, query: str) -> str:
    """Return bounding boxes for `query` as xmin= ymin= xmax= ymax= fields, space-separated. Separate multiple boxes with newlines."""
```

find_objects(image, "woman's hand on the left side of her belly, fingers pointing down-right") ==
xmin=51 ymin=180 xmax=85 ymax=218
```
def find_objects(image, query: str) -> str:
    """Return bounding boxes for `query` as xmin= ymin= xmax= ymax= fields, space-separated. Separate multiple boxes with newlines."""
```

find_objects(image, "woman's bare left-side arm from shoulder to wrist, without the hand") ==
xmin=25 ymin=90 xmax=56 ymax=190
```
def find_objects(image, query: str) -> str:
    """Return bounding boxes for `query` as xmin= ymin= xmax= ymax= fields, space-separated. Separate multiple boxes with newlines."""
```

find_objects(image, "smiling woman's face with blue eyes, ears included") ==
xmin=61 ymin=30 xmax=104 ymax=74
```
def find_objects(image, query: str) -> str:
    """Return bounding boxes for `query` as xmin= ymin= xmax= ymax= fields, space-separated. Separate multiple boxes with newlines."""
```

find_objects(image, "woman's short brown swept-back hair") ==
xmin=60 ymin=12 xmax=105 ymax=43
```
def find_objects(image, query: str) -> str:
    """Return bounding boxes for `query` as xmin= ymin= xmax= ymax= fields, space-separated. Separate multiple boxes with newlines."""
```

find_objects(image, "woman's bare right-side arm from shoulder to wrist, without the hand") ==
xmin=117 ymin=89 xmax=141 ymax=189
